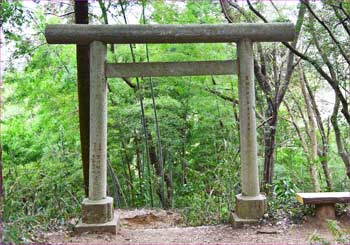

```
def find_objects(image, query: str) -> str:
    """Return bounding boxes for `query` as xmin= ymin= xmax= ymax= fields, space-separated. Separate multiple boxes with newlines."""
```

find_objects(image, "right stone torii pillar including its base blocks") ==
xmin=232 ymin=39 xmax=267 ymax=227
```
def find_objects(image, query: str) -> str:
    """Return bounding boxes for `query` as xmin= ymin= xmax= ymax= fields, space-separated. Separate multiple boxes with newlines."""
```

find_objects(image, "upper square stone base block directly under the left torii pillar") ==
xmin=82 ymin=197 xmax=114 ymax=224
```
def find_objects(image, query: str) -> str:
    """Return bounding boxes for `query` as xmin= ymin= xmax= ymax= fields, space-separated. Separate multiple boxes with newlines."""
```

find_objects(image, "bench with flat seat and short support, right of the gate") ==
xmin=296 ymin=192 xmax=350 ymax=220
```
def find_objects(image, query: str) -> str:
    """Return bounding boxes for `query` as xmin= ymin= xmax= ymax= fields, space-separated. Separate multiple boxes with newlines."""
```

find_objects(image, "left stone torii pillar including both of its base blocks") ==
xmin=77 ymin=41 xmax=118 ymax=234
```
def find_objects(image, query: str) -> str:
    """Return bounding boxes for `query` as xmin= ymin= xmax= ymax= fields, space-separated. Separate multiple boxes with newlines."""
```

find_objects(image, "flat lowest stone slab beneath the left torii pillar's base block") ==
xmin=75 ymin=217 xmax=120 ymax=235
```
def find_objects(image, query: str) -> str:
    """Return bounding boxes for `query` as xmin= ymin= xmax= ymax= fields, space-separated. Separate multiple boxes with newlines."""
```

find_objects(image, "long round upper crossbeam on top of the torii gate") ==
xmin=45 ymin=23 xmax=295 ymax=44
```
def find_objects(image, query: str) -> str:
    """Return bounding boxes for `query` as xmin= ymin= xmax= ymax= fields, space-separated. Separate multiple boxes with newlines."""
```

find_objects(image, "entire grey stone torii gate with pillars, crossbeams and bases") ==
xmin=45 ymin=23 xmax=295 ymax=234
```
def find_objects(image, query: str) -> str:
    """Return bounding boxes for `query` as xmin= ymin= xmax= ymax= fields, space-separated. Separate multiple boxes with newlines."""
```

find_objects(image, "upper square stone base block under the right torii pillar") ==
xmin=236 ymin=194 xmax=267 ymax=220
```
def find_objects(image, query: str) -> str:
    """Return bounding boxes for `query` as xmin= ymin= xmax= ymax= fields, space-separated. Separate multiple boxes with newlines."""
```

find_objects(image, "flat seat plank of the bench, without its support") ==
xmin=296 ymin=192 xmax=350 ymax=204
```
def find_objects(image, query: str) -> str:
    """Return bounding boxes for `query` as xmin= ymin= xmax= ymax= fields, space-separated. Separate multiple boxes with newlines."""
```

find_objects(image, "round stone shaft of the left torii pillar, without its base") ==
xmin=89 ymin=41 xmax=107 ymax=200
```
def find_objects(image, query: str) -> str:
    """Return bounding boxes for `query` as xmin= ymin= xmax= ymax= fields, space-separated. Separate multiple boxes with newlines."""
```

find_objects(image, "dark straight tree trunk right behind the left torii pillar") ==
xmin=74 ymin=0 xmax=90 ymax=196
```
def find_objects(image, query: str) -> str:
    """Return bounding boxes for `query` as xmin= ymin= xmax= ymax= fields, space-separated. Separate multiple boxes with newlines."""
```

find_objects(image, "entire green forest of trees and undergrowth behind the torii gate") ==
xmin=0 ymin=0 xmax=350 ymax=242
